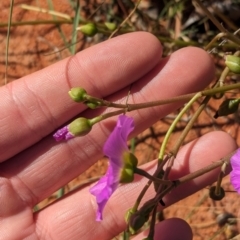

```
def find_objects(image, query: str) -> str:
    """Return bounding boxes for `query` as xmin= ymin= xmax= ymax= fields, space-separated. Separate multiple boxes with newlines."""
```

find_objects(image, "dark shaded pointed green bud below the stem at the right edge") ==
xmin=214 ymin=98 xmax=240 ymax=118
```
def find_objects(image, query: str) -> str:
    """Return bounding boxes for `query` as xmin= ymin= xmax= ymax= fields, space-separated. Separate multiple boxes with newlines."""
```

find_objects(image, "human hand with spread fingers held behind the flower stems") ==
xmin=0 ymin=32 xmax=236 ymax=240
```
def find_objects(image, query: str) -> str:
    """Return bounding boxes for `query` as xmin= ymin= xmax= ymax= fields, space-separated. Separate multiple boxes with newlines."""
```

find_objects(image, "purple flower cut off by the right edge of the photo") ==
xmin=230 ymin=148 xmax=240 ymax=194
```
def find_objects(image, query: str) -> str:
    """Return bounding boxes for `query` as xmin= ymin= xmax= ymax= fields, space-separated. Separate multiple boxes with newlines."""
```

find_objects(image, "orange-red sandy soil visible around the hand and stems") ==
xmin=0 ymin=0 xmax=240 ymax=240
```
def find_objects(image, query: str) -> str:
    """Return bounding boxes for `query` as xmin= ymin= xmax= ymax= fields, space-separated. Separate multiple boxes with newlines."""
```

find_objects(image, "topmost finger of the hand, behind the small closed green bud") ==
xmin=0 ymin=32 xmax=162 ymax=162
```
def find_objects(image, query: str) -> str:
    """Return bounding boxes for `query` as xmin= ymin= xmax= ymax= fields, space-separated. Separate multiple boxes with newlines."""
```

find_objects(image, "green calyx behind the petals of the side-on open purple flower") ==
xmin=120 ymin=152 xmax=138 ymax=183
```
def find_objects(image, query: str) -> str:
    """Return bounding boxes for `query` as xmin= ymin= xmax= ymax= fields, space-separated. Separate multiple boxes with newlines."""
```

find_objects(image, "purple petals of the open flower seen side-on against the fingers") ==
xmin=90 ymin=115 xmax=134 ymax=221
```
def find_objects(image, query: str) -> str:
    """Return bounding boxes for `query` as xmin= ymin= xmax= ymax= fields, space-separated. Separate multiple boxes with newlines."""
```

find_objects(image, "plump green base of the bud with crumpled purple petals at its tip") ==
xmin=68 ymin=117 xmax=92 ymax=136
